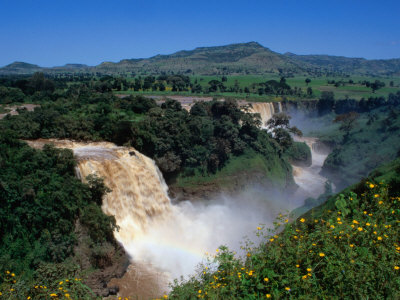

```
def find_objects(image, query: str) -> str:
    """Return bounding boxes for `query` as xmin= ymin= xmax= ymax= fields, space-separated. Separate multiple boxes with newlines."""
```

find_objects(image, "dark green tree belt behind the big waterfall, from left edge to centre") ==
xmin=0 ymin=74 xmax=304 ymax=180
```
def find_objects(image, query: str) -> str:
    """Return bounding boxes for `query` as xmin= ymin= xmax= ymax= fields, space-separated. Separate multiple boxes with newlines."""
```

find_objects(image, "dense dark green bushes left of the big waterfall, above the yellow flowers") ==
xmin=0 ymin=132 xmax=115 ymax=283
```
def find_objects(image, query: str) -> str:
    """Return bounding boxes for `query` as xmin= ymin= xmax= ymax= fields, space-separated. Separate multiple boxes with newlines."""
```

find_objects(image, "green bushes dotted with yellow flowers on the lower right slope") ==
xmin=169 ymin=182 xmax=400 ymax=299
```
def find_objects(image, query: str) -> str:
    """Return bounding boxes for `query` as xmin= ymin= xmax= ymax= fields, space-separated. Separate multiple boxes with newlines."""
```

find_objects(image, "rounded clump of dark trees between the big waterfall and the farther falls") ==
xmin=130 ymin=100 xmax=283 ymax=179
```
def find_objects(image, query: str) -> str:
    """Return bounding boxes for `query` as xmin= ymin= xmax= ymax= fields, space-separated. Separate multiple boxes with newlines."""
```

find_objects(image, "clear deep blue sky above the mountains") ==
xmin=0 ymin=0 xmax=400 ymax=67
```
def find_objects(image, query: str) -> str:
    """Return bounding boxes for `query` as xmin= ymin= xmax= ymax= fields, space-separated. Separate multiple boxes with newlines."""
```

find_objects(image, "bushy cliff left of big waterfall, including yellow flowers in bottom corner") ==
xmin=0 ymin=131 xmax=118 ymax=299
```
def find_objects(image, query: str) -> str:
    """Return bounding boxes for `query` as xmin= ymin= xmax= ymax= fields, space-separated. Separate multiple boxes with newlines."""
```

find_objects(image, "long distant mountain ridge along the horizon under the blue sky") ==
xmin=0 ymin=42 xmax=400 ymax=75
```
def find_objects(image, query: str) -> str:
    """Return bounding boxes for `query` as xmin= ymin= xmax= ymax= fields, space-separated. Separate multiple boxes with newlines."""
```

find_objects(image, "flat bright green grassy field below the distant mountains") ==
xmin=117 ymin=75 xmax=400 ymax=101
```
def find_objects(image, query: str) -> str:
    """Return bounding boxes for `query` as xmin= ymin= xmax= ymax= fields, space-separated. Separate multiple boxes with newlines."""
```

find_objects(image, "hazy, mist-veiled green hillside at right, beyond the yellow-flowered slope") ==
xmin=323 ymin=106 xmax=400 ymax=188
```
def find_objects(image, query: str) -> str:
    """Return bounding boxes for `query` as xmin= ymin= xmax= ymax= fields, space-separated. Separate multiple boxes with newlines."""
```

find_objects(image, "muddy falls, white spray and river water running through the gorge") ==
xmin=28 ymin=103 xmax=327 ymax=299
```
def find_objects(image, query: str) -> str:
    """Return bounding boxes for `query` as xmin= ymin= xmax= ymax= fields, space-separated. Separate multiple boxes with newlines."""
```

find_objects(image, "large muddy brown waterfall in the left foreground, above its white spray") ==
xmin=28 ymin=140 xmax=172 ymax=245
